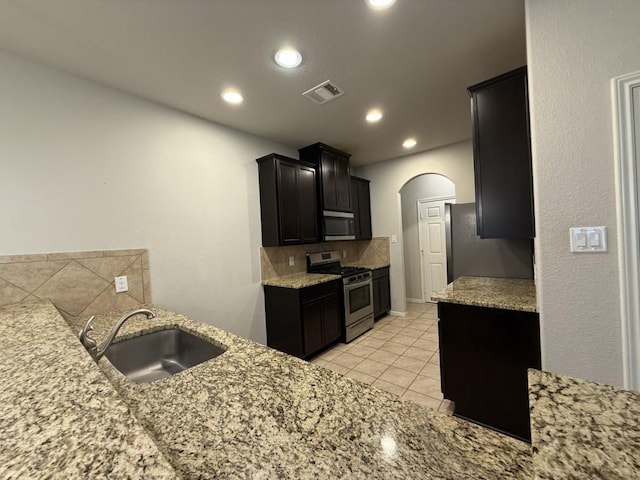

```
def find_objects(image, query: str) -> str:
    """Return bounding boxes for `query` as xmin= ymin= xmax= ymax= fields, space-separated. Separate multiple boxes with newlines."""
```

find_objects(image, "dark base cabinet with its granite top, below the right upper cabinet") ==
xmin=432 ymin=276 xmax=541 ymax=441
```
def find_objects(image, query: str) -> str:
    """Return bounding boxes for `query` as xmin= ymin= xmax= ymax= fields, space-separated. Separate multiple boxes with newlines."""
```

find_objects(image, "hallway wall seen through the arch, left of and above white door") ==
xmin=400 ymin=173 xmax=456 ymax=300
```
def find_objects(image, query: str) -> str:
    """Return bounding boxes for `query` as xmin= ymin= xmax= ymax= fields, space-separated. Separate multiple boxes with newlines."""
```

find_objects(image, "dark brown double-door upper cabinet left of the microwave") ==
xmin=256 ymin=153 xmax=319 ymax=247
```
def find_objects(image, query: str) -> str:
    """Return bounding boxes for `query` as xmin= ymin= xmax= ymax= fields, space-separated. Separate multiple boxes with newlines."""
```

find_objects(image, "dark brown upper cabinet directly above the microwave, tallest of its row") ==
xmin=298 ymin=143 xmax=353 ymax=212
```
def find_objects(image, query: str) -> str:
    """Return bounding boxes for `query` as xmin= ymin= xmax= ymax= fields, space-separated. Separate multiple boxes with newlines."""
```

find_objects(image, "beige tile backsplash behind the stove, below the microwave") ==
xmin=260 ymin=237 xmax=391 ymax=280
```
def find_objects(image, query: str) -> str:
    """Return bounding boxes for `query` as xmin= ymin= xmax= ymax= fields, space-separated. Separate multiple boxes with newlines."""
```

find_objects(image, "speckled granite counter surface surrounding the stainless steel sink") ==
xmin=67 ymin=307 xmax=532 ymax=480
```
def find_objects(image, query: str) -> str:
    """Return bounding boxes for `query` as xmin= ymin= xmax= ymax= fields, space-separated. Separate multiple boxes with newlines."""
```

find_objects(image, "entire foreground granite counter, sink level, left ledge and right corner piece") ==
xmin=0 ymin=302 xmax=640 ymax=480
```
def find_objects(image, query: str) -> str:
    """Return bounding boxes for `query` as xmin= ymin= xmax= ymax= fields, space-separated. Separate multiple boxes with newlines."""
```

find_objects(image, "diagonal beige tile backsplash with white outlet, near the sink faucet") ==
xmin=0 ymin=249 xmax=151 ymax=320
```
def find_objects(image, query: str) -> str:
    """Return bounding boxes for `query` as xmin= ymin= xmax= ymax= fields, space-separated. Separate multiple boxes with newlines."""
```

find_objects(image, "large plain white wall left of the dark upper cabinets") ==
xmin=0 ymin=52 xmax=297 ymax=342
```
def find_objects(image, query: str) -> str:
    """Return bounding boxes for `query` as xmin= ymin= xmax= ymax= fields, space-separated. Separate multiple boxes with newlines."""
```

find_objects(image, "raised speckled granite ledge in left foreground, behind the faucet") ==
xmin=0 ymin=302 xmax=179 ymax=480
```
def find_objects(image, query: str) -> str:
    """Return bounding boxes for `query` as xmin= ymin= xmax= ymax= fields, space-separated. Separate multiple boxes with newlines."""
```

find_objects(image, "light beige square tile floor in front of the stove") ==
xmin=311 ymin=303 xmax=453 ymax=414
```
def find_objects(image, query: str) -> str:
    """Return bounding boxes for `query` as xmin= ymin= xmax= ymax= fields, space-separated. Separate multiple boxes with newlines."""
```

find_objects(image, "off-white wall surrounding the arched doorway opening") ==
xmin=357 ymin=140 xmax=475 ymax=313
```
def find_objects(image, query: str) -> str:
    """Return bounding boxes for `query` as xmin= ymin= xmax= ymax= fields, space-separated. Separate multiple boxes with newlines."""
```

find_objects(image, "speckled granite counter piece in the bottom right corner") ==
xmin=529 ymin=370 xmax=640 ymax=480
